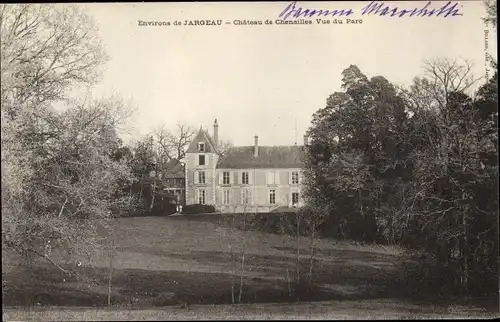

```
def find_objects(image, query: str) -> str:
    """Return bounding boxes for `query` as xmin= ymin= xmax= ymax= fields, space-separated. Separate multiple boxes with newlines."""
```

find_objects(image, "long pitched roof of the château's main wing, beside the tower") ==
xmin=217 ymin=145 xmax=303 ymax=169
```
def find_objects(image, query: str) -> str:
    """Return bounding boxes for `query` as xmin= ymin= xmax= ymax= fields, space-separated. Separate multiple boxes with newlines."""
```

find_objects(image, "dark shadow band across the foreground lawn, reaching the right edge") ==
xmin=2 ymin=252 xmax=498 ymax=311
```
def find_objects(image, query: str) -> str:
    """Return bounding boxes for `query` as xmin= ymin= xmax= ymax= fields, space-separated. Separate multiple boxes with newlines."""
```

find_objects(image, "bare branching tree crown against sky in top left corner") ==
xmin=0 ymin=4 xmax=108 ymax=109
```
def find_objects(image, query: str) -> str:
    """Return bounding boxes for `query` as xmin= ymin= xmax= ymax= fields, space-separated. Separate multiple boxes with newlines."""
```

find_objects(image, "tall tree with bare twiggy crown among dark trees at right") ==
xmin=405 ymin=59 xmax=495 ymax=290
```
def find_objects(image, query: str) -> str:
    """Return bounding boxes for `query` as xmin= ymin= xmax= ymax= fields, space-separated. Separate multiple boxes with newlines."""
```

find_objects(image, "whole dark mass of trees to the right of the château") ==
xmin=298 ymin=59 xmax=498 ymax=291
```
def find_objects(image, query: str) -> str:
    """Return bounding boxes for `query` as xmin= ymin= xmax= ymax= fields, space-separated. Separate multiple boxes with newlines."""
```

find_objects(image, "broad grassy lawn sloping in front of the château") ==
xmin=2 ymin=215 xmax=498 ymax=320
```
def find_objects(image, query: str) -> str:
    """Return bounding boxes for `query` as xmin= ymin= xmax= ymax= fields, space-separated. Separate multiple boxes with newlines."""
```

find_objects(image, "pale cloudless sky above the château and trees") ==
xmin=81 ymin=1 xmax=496 ymax=145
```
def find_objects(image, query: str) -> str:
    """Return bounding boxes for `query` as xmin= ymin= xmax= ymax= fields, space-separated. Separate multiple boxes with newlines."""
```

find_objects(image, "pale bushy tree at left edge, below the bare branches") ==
xmin=2 ymin=96 xmax=135 ymax=270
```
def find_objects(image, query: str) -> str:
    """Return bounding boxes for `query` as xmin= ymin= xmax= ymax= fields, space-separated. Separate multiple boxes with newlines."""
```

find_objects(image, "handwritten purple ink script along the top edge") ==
xmin=279 ymin=0 xmax=463 ymax=20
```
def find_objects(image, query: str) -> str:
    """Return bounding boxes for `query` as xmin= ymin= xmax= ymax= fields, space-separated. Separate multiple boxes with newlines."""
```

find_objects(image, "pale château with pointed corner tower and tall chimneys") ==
xmin=185 ymin=120 xmax=304 ymax=213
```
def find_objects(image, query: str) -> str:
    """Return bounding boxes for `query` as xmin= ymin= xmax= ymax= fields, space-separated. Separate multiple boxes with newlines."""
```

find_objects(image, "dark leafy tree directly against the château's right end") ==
xmin=306 ymin=66 xmax=410 ymax=241
